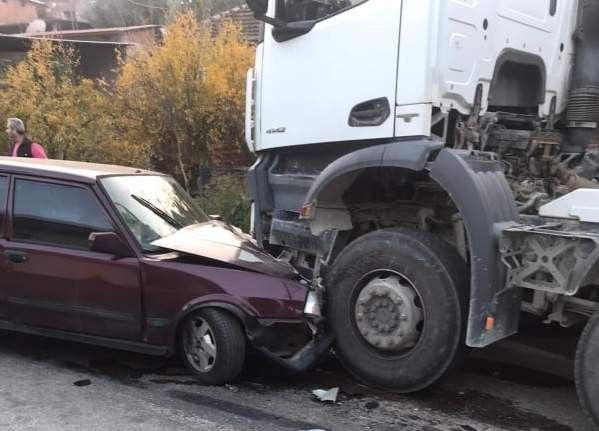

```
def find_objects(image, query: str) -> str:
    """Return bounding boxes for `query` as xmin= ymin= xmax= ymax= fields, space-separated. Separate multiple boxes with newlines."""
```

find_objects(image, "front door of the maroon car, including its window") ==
xmin=0 ymin=177 xmax=141 ymax=340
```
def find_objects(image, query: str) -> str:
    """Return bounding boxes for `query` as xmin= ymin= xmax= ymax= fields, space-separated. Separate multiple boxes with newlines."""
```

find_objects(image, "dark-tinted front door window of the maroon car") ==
xmin=12 ymin=179 xmax=114 ymax=250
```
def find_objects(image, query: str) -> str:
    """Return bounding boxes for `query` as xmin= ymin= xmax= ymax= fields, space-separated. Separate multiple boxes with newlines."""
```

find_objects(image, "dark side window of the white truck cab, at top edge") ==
xmin=276 ymin=0 xmax=368 ymax=22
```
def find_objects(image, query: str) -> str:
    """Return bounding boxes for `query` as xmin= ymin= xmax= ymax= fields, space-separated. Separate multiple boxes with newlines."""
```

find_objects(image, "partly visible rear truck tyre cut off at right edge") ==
xmin=574 ymin=312 xmax=599 ymax=426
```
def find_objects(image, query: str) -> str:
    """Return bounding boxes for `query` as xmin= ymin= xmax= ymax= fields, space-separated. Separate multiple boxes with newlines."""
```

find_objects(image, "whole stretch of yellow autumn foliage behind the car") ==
xmin=0 ymin=13 xmax=254 ymax=187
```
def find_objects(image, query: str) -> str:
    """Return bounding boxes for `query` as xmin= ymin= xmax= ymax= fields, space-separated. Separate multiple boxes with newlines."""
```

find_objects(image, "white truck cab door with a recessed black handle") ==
xmin=256 ymin=0 xmax=404 ymax=150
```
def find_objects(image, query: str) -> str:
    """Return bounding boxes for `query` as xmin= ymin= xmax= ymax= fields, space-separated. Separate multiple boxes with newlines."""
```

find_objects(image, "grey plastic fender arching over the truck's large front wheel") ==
xmin=304 ymin=143 xmax=520 ymax=347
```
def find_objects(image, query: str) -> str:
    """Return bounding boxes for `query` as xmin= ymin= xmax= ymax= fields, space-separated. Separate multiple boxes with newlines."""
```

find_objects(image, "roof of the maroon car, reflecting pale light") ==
xmin=0 ymin=157 xmax=163 ymax=183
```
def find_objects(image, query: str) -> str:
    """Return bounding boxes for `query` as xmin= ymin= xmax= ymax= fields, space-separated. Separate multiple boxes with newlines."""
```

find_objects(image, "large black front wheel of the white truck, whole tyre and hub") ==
xmin=328 ymin=229 xmax=468 ymax=392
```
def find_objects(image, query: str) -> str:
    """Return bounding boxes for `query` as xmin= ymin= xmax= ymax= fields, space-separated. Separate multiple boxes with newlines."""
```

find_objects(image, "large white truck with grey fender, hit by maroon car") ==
xmin=246 ymin=0 xmax=599 ymax=423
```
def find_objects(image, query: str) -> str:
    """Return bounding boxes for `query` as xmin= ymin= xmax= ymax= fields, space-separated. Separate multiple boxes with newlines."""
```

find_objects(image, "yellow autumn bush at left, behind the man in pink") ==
xmin=0 ymin=41 xmax=145 ymax=164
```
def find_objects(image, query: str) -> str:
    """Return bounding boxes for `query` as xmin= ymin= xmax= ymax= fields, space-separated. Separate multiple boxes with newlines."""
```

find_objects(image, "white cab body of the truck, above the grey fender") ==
xmin=251 ymin=0 xmax=577 ymax=151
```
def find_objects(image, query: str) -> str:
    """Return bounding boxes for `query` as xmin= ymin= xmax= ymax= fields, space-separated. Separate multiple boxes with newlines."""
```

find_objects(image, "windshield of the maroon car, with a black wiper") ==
xmin=101 ymin=175 xmax=209 ymax=252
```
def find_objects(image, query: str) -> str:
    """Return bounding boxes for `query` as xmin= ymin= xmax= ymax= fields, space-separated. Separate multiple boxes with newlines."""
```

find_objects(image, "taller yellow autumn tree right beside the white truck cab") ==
xmin=116 ymin=12 xmax=253 ymax=189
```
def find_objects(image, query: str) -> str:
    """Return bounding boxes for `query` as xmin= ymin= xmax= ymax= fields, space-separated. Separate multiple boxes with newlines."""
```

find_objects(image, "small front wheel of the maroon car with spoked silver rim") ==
xmin=180 ymin=308 xmax=245 ymax=385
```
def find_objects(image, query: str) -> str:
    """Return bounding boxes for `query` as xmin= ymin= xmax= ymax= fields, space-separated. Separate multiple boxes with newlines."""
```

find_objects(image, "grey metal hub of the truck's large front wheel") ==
xmin=355 ymin=275 xmax=422 ymax=352
